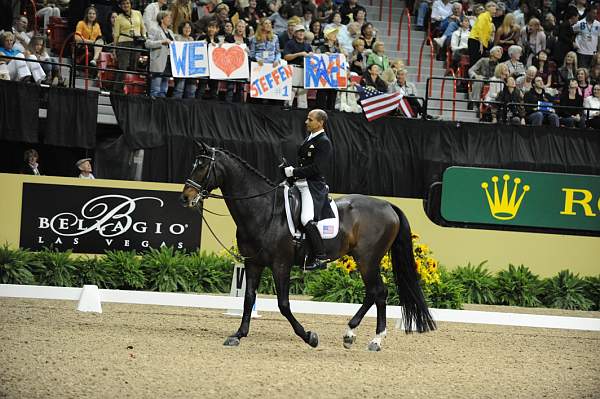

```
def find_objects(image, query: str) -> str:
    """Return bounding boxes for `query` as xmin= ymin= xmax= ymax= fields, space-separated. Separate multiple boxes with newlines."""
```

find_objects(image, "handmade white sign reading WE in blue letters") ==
xmin=170 ymin=42 xmax=208 ymax=78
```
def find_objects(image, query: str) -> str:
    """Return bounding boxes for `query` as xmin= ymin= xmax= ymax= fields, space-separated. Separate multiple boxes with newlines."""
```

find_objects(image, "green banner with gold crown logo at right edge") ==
xmin=441 ymin=167 xmax=600 ymax=232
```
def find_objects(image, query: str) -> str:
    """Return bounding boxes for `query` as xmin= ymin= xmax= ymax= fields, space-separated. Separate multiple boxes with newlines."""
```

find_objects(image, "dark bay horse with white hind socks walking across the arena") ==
xmin=180 ymin=143 xmax=436 ymax=351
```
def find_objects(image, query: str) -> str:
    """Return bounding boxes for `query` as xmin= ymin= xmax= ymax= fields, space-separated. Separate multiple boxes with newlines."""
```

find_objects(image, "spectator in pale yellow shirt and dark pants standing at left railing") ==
xmin=113 ymin=0 xmax=146 ymax=91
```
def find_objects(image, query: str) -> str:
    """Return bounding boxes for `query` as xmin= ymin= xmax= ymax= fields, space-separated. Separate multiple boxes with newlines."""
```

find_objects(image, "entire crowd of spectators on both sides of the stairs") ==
xmin=0 ymin=0 xmax=600 ymax=128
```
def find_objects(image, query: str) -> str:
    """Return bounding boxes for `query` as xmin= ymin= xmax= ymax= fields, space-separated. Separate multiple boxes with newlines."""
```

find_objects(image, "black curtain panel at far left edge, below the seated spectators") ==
xmin=0 ymin=80 xmax=41 ymax=143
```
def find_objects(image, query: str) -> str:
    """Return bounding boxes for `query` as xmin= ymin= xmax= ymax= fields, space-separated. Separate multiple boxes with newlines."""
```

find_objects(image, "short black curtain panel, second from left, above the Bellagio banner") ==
xmin=44 ymin=88 xmax=98 ymax=149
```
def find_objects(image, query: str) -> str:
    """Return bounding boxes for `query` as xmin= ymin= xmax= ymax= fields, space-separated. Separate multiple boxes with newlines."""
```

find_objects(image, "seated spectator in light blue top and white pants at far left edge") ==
xmin=0 ymin=32 xmax=46 ymax=83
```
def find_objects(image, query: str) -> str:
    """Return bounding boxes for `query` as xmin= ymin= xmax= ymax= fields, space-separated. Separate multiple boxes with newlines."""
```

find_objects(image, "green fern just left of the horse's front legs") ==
xmin=186 ymin=251 xmax=233 ymax=293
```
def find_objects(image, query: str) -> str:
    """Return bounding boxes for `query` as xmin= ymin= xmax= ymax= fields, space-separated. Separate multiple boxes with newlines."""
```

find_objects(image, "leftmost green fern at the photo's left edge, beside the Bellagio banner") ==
xmin=0 ymin=243 xmax=41 ymax=284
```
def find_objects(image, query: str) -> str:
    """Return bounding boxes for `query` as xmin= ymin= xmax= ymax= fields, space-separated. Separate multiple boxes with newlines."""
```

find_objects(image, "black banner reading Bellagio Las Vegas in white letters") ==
xmin=20 ymin=183 xmax=201 ymax=253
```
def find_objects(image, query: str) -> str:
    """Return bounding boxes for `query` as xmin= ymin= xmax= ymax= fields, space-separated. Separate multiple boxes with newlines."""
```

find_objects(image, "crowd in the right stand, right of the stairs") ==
xmin=422 ymin=0 xmax=600 ymax=128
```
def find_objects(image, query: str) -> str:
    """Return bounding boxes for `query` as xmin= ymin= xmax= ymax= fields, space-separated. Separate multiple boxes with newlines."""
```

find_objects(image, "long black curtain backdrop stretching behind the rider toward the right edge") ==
xmin=112 ymin=96 xmax=600 ymax=198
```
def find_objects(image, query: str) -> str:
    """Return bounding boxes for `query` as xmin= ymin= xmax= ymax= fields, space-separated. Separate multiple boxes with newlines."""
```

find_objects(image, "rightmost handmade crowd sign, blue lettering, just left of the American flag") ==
xmin=304 ymin=54 xmax=348 ymax=89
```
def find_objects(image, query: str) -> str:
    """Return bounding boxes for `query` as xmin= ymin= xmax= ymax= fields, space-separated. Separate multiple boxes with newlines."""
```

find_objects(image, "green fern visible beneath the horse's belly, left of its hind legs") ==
xmin=307 ymin=266 xmax=365 ymax=303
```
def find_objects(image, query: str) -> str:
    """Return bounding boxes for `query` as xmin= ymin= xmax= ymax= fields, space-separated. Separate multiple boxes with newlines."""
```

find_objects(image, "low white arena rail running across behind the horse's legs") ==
xmin=0 ymin=284 xmax=600 ymax=331
